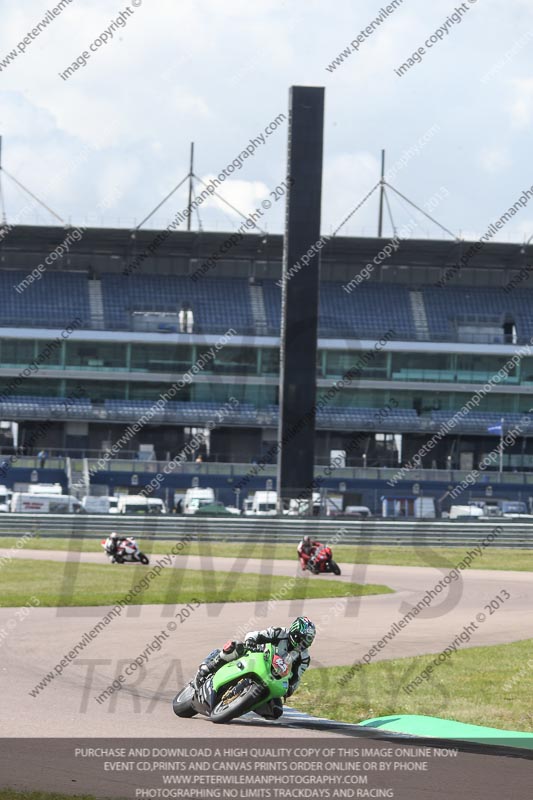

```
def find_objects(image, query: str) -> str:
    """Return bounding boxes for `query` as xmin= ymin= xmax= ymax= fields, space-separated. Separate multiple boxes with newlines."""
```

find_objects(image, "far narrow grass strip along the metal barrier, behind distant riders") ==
xmin=0 ymin=535 xmax=533 ymax=572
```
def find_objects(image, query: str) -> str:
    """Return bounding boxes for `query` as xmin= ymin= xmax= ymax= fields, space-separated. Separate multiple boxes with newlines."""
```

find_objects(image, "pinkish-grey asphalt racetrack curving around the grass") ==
xmin=4 ymin=550 xmax=533 ymax=738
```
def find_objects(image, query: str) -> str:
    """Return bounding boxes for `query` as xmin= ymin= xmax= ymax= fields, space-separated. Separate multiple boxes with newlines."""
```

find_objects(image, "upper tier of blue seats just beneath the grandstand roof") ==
xmin=0 ymin=264 xmax=533 ymax=342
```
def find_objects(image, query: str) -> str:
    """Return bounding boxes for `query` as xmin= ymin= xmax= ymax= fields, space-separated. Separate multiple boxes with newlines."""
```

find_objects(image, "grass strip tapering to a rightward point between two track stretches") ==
xmin=0 ymin=559 xmax=392 ymax=608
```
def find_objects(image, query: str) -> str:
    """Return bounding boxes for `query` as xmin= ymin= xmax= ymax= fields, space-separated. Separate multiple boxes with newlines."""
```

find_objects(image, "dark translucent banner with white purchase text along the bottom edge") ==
xmin=0 ymin=731 xmax=533 ymax=800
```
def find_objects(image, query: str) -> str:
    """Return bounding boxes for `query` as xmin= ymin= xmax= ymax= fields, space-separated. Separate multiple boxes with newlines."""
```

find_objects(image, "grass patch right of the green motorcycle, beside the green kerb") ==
xmin=290 ymin=640 xmax=533 ymax=732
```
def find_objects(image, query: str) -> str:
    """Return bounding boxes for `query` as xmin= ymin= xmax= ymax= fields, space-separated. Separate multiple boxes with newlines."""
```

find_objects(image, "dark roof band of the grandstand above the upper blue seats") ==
xmin=0 ymin=225 xmax=533 ymax=284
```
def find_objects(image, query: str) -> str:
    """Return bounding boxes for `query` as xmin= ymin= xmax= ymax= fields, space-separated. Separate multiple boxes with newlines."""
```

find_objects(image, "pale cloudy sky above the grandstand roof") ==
xmin=0 ymin=0 xmax=533 ymax=242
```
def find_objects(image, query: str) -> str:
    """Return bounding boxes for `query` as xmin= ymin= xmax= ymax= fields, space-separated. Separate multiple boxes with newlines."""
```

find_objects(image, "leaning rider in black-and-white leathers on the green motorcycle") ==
xmin=195 ymin=617 xmax=316 ymax=719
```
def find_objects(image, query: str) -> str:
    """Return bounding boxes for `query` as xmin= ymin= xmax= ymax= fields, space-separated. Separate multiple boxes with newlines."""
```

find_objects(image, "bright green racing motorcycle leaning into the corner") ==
xmin=172 ymin=644 xmax=292 ymax=723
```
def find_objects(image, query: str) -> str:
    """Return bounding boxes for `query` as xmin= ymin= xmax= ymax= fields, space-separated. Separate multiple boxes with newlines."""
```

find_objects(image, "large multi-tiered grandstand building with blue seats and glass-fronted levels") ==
xmin=0 ymin=226 xmax=533 ymax=511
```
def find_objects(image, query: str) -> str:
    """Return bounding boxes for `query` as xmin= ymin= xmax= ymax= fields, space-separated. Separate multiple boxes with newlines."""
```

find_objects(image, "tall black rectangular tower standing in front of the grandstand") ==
xmin=277 ymin=86 xmax=324 ymax=510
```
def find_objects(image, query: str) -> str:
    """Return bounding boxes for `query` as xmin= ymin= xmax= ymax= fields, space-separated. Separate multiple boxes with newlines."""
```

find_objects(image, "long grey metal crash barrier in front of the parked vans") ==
xmin=0 ymin=514 xmax=533 ymax=549
